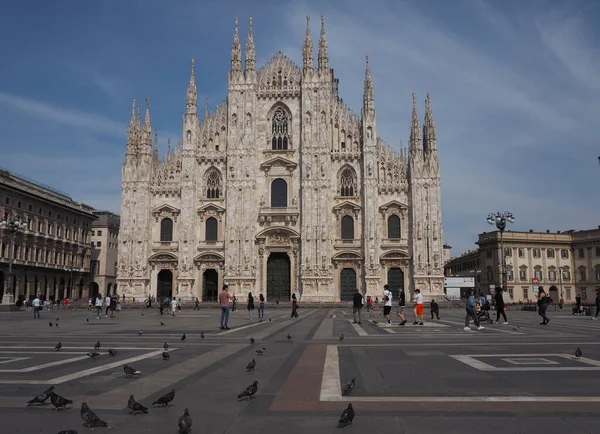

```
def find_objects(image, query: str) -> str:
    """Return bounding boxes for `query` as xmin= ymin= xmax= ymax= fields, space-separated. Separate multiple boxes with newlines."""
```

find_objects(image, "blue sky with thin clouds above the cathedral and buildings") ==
xmin=0 ymin=0 xmax=600 ymax=255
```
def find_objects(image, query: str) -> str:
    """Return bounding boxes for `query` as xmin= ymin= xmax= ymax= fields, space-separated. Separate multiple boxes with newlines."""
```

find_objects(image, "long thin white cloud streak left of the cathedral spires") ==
xmin=0 ymin=92 xmax=127 ymax=137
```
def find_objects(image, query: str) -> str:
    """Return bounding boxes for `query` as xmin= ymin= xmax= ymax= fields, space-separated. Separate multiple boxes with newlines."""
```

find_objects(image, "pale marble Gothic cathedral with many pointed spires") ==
xmin=117 ymin=19 xmax=444 ymax=301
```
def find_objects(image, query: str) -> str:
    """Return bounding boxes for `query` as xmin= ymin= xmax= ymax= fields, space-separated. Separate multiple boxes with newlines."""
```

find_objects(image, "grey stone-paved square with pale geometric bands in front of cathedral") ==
xmin=0 ymin=308 xmax=600 ymax=434
